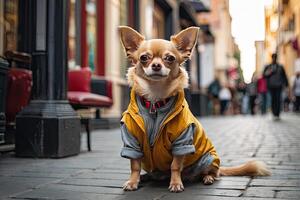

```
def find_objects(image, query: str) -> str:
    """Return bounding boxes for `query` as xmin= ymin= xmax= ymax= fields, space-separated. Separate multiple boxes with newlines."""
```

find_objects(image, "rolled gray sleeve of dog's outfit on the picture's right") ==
xmin=172 ymin=124 xmax=196 ymax=156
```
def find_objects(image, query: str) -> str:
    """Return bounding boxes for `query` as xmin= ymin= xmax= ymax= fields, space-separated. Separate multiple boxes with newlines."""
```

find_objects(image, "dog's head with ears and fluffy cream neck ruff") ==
xmin=119 ymin=26 xmax=199 ymax=101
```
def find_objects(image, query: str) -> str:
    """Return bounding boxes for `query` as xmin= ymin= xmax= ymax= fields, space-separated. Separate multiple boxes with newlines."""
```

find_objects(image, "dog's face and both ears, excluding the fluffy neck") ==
xmin=119 ymin=26 xmax=199 ymax=81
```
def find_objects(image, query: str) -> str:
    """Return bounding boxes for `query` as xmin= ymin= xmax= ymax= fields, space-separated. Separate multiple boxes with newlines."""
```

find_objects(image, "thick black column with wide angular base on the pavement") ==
xmin=16 ymin=0 xmax=80 ymax=158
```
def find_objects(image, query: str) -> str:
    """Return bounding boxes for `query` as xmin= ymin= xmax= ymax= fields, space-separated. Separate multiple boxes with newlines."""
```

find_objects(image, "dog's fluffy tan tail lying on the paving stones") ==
xmin=220 ymin=161 xmax=271 ymax=176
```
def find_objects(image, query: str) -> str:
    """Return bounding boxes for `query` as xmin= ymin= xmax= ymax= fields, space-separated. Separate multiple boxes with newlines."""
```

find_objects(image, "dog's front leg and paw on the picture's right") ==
xmin=169 ymin=156 xmax=184 ymax=192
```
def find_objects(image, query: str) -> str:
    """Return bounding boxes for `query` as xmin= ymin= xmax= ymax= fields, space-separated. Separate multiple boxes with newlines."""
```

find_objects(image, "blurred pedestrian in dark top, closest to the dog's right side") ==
xmin=207 ymin=77 xmax=221 ymax=114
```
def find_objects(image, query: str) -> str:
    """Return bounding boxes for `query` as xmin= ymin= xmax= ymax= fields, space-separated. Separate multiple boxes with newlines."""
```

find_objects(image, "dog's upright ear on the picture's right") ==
xmin=171 ymin=27 xmax=199 ymax=59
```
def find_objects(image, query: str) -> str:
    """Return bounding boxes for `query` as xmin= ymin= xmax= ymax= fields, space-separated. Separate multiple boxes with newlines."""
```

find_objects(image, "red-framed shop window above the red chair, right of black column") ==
xmin=68 ymin=0 xmax=105 ymax=76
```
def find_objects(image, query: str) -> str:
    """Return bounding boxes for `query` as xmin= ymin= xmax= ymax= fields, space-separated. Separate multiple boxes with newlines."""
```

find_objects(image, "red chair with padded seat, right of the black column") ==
xmin=68 ymin=67 xmax=113 ymax=151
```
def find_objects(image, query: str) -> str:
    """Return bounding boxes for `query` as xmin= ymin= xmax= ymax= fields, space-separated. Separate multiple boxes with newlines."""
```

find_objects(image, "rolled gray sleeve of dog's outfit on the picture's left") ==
xmin=121 ymin=123 xmax=143 ymax=159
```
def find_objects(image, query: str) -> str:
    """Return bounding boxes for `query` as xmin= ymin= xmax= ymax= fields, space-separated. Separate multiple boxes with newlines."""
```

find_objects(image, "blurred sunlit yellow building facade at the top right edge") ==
xmin=265 ymin=0 xmax=300 ymax=80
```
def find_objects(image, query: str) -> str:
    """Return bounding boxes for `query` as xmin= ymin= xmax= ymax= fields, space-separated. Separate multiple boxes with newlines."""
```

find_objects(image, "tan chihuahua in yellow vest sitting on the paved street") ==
xmin=119 ymin=26 xmax=270 ymax=192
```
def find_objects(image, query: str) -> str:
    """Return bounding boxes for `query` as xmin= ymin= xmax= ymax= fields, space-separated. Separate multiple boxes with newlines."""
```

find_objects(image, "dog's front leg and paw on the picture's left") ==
xmin=123 ymin=159 xmax=141 ymax=191
